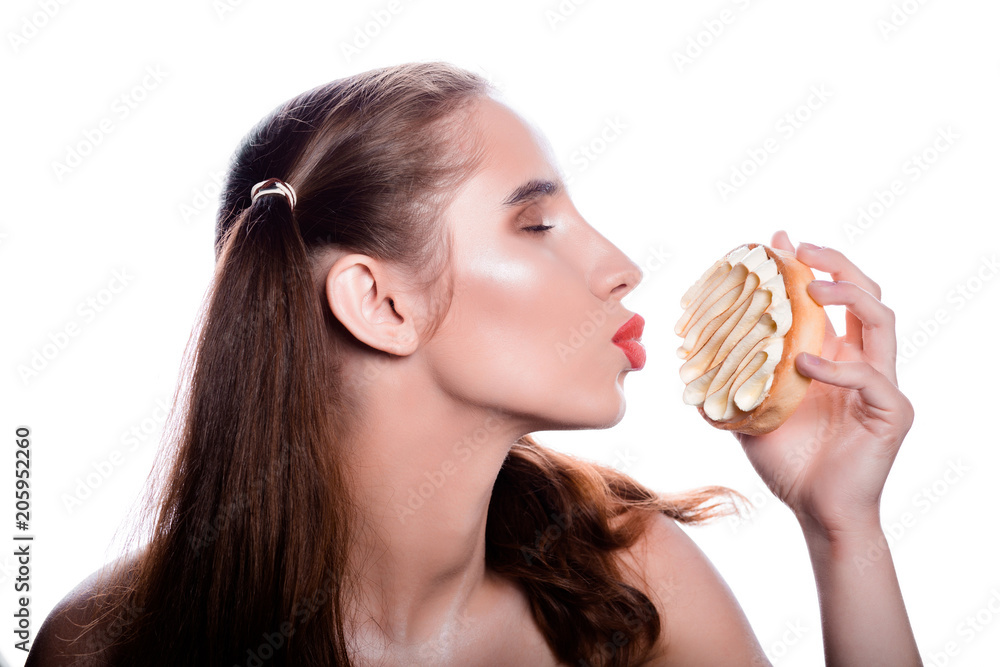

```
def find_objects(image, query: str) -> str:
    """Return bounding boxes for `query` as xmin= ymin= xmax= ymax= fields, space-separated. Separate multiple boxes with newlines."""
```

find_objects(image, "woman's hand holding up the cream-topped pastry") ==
xmin=736 ymin=231 xmax=913 ymax=536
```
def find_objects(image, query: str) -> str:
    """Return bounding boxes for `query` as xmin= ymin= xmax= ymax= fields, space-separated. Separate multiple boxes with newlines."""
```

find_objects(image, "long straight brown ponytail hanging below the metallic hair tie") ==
xmin=100 ymin=190 xmax=350 ymax=665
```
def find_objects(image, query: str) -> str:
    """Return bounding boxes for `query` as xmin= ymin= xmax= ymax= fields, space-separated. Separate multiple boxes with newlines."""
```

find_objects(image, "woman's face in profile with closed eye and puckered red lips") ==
xmin=425 ymin=98 xmax=642 ymax=431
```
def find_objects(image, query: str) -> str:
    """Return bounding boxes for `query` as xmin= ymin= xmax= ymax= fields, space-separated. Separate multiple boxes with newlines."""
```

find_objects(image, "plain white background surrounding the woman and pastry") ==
xmin=0 ymin=0 xmax=1000 ymax=665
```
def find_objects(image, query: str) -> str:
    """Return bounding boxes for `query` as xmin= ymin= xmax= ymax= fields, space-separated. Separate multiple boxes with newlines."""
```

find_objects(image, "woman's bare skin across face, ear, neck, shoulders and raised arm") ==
xmin=25 ymin=98 xmax=919 ymax=667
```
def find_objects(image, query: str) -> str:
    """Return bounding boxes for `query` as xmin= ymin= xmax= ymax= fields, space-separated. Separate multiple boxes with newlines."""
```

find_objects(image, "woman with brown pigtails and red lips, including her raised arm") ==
xmin=28 ymin=63 xmax=919 ymax=666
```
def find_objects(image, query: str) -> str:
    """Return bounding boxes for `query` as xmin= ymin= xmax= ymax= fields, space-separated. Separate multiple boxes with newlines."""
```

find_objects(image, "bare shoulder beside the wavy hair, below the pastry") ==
xmin=621 ymin=514 xmax=770 ymax=666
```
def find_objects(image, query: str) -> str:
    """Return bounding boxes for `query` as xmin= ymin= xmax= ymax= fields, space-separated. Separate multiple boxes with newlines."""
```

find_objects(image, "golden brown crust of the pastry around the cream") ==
xmin=698 ymin=243 xmax=826 ymax=435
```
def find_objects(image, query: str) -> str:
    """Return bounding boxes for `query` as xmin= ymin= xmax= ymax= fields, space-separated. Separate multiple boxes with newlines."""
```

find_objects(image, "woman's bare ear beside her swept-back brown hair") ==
xmin=326 ymin=254 xmax=419 ymax=356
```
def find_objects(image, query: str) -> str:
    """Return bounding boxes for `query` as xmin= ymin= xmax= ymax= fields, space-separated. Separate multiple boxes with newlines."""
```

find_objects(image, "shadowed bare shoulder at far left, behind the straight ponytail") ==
xmin=24 ymin=561 xmax=139 ymax=667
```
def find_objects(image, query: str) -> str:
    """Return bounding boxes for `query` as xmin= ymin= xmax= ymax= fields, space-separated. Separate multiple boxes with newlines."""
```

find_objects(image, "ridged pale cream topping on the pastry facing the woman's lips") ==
xmin=674 ymin=245 xmax=792 ymax=421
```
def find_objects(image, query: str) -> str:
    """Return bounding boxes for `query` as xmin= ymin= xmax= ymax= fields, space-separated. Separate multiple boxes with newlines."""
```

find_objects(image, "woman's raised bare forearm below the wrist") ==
xmin=800 ymin=520 xmax=923 ymax=667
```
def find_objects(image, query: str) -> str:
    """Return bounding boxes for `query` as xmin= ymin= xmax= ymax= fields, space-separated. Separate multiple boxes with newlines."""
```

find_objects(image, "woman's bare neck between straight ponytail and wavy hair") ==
xmin=348 ymin=362 xmax=528 ymax=642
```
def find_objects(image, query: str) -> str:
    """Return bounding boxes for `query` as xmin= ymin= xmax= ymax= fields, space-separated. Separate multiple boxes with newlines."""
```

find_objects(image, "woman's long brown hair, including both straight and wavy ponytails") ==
xmin=72 ymin=63 xmax=744 ymax=667
